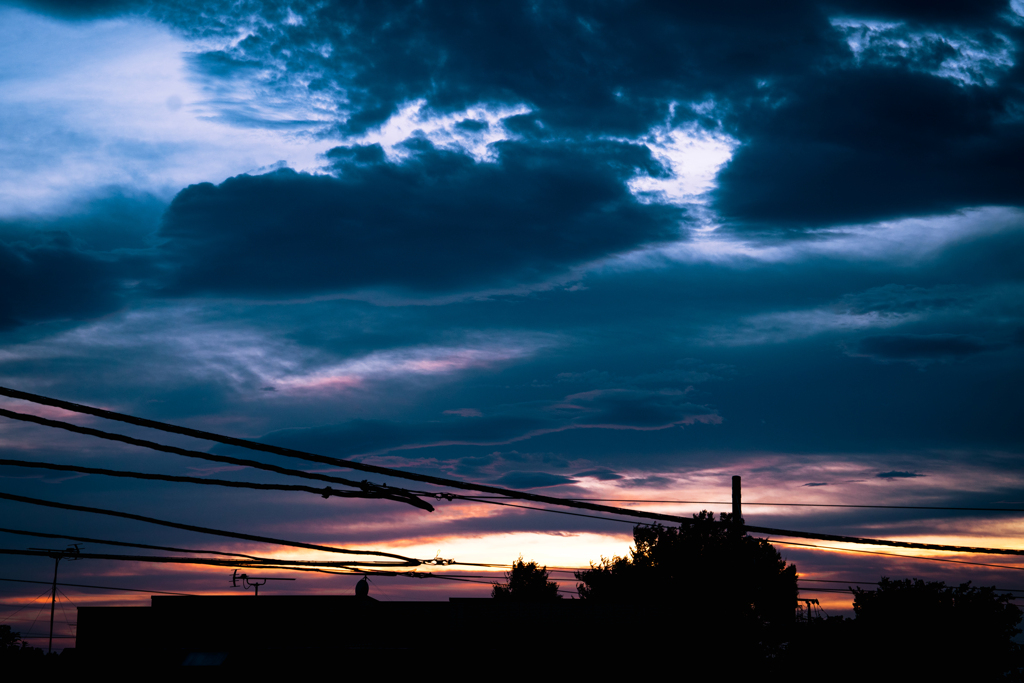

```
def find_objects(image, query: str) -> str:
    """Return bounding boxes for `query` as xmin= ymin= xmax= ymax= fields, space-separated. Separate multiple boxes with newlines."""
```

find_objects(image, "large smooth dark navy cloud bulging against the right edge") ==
xmin=715 ymin=68 xmax=1024 ymax=227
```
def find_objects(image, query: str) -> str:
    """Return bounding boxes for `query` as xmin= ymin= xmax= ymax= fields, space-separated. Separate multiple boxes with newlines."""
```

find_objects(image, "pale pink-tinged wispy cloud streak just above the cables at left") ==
xmin=0 ymin=304 xmax=558 ymax=393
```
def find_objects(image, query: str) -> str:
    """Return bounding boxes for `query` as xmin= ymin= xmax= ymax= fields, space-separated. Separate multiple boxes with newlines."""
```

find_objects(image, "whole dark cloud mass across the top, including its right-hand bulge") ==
xmin=151 ymin=1 xmax=1024 ymax=233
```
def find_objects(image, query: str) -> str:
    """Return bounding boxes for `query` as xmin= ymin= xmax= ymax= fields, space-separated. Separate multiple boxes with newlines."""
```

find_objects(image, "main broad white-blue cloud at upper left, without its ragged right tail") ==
xmin=0 ymin=8 xmax=332 ymax=217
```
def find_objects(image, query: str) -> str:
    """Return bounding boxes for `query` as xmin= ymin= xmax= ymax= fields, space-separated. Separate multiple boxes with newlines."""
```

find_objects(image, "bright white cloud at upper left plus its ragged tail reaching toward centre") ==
xmin=0 ymin=8 xmax=544 ymax=218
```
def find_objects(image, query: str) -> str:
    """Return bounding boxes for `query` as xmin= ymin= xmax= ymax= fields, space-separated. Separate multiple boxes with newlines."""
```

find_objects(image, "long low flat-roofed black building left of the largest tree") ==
xmin=77 ymin=595 xmax=667 ymax=673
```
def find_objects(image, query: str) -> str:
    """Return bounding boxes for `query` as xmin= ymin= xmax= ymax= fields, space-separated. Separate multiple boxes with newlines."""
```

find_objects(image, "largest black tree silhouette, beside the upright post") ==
xmin=575 ymin=510 xmax=797 ymax=648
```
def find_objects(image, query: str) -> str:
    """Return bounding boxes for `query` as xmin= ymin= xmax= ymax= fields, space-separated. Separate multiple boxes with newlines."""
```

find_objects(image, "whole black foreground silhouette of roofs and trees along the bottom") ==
xmin=8 ymin=512 xmax=1022 ymax=683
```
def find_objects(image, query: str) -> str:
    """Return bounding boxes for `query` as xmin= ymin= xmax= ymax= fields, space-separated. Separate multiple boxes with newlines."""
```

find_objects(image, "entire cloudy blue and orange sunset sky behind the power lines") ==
xmin=0 ymin=0 xmax=1024 ymax=644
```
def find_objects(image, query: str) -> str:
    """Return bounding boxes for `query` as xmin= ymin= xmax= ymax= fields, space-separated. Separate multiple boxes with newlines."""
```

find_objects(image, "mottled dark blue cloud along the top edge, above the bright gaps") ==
xmin=163 ymin=1 xmax=841 ymax=134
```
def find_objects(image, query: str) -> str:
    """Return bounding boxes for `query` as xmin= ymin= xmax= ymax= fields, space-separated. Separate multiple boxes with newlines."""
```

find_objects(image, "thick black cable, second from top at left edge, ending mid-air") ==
xmin=0 ymin=409 xmax=434 ymax=512
